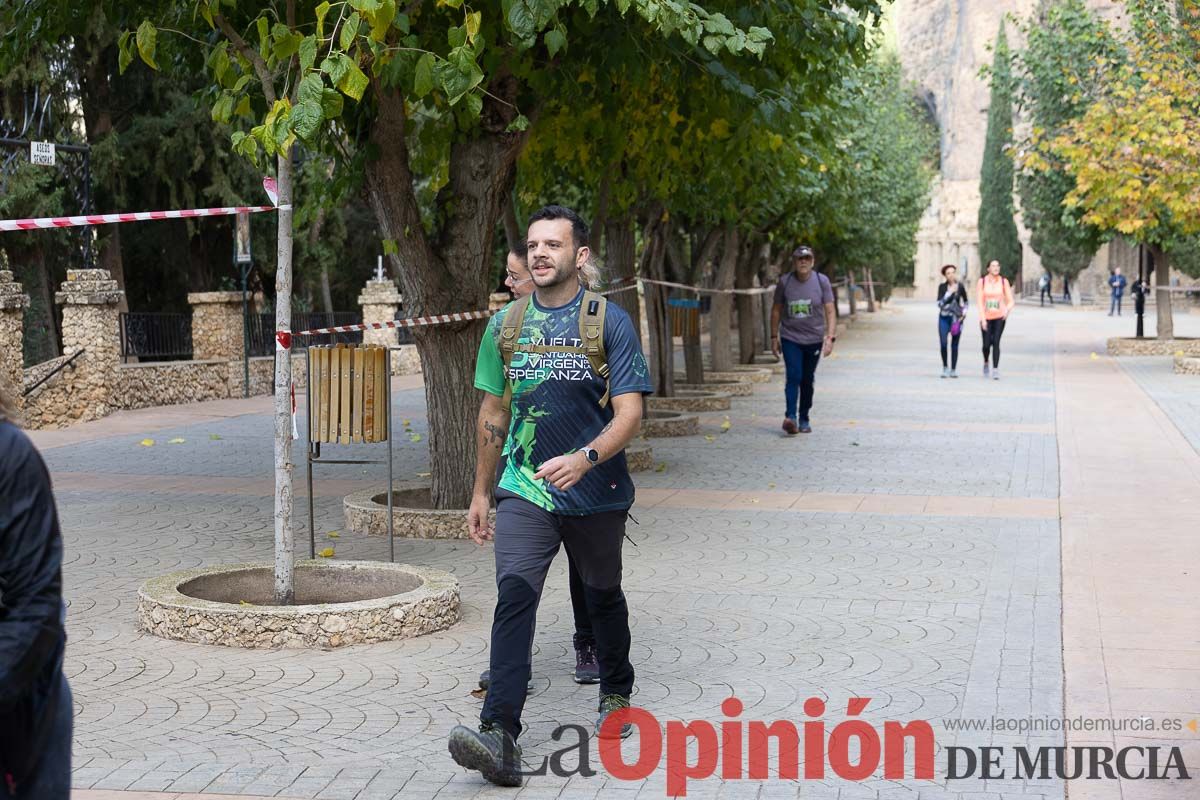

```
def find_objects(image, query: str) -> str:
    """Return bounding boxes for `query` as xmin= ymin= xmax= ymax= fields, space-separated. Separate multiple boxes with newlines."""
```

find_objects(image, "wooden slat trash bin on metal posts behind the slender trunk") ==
xmin=306 ymin=344 xmax=396 ymax=561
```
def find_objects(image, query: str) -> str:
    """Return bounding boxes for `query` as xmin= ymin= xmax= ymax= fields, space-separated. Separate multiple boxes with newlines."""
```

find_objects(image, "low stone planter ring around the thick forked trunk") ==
xmin=342 ymin=482 xmax=484 ymax=539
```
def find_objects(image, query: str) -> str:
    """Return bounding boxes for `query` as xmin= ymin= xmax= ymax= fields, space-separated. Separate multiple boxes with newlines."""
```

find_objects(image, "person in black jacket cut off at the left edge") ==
xmin=0 ymin=383 xmax=72 ymax=800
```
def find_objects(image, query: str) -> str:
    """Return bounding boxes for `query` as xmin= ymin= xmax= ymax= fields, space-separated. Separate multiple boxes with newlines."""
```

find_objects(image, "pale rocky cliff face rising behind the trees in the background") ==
xmin=890 ymin=0 xmax=1122 ymax=297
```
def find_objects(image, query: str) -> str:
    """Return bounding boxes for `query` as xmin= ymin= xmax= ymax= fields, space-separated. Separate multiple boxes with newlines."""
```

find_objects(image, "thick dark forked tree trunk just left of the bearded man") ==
xmin=366 ymin=77 xmax=524 ymax=509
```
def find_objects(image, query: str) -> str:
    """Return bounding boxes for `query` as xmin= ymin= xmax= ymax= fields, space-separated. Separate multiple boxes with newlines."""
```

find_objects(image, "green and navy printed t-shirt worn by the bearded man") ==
xmin=475 ymin=290 xmax=653 ymax=515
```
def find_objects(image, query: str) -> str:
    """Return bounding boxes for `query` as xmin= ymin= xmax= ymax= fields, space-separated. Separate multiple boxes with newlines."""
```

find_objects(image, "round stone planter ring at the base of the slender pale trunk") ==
xmin=138 ymin=560 xmax=461 ymax=648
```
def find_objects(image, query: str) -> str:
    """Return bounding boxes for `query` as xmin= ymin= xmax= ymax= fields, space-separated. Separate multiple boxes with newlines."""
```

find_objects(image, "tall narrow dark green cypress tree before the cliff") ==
xmin=979 ymin=20 xmax=1021 ymax=283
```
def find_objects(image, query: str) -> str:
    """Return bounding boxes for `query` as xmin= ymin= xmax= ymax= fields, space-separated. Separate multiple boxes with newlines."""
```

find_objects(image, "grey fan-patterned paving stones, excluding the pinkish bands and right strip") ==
xmin=56 ymin=305 xmax=1070 ymax=800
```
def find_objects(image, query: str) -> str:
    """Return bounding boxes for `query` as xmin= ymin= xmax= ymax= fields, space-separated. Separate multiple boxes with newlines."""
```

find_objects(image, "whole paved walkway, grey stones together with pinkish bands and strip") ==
xmin=36 ymin=303 xmax=1200 ymax=800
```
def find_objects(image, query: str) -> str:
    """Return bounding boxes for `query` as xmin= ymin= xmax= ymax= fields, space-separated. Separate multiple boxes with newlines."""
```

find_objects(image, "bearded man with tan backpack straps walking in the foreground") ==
xmin=449 ymin=205 xmax=652 ymax=786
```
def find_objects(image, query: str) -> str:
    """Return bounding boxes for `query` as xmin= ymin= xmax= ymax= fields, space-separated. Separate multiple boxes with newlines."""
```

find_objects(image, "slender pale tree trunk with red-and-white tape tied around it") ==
xmin=275 ymin=148 xmax=295 ymax=606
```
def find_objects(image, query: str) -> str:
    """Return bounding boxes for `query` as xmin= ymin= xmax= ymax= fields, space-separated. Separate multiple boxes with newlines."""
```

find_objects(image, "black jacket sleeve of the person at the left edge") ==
xmin=0 ymin=422 xmax=65 ymax=711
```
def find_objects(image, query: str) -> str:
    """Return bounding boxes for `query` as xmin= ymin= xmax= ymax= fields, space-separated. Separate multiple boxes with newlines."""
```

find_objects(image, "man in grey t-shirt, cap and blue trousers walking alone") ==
xmin=770 ymin=246 xmax=838 ymax=435
